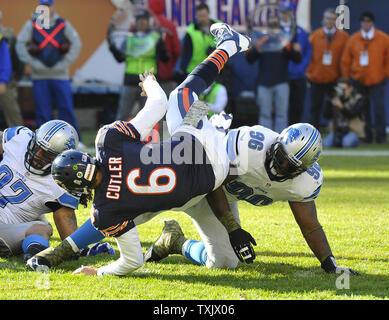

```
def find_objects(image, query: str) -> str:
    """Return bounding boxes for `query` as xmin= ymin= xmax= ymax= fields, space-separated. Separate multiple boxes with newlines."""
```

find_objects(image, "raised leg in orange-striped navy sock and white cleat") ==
xmin=166 ymin=23 xmax=250 ymax=135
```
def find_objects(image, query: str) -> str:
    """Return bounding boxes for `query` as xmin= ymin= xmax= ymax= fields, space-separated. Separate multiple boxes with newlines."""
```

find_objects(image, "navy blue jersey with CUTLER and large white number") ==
xmin=92 ymin=121 xmax=215 ymax=236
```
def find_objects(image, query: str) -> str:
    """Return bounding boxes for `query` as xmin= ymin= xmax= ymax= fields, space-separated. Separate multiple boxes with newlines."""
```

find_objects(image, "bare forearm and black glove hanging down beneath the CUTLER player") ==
xmin=206 ymin=187 xmax=257 ymax=263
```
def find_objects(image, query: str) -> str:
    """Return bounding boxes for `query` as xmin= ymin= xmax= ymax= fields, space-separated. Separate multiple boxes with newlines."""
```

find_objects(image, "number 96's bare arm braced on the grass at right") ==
xmin=289 ymin=201 xmax=358 ymax=274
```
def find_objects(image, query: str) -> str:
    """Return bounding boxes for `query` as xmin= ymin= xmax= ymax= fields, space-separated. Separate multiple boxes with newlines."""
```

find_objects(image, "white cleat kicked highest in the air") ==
xmin=210 ymin=22 xmax=251 ymax=52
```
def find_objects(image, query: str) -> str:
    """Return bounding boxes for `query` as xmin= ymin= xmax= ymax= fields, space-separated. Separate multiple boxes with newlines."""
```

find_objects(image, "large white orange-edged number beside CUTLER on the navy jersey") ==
xmin=126 ymin=167 xmax=177 ymax=194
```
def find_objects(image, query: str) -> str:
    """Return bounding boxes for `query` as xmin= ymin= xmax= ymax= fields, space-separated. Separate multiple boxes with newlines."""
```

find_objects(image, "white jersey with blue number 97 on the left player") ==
xmin=0 ymin=127 xmax=79 ymax=224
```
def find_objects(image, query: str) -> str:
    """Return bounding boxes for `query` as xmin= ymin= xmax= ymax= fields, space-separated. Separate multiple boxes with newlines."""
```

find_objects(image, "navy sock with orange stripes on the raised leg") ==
xmin=179 ymin=48 xmax=230 ymax=96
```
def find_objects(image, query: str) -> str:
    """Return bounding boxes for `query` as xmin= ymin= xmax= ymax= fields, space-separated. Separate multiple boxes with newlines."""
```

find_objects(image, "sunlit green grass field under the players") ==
xmin=0 ymin=139 xmax=389 ymax=300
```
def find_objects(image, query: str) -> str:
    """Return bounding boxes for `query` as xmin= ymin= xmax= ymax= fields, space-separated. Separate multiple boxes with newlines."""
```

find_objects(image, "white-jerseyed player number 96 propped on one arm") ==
xmin=145 ymin=121 xmax=358 ymax=274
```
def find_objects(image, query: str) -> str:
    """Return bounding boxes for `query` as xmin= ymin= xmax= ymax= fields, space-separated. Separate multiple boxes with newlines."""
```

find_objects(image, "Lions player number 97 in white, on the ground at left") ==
xmin=0 ymin=120 xmax=112 ymax=261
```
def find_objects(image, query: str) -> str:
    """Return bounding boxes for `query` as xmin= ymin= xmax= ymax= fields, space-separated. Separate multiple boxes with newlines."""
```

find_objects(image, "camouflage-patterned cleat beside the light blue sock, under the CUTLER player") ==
xmin=144 ymin=220 xmax=186 ymax=262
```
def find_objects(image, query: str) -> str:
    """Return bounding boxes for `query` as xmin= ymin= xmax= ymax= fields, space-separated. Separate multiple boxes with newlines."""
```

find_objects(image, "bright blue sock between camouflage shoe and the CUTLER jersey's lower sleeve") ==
xmin=66 ymin=219 xmax=105 ymax=252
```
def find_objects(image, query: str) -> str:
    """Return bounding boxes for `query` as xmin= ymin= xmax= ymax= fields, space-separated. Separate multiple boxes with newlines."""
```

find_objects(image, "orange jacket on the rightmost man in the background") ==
xmin=342 ymin=29 xmax=389 ymax=86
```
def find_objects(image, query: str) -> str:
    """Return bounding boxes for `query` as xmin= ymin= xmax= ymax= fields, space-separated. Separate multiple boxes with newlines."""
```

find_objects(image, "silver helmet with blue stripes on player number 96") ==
xmin=265 ymin=123 xmax=323 ymax=182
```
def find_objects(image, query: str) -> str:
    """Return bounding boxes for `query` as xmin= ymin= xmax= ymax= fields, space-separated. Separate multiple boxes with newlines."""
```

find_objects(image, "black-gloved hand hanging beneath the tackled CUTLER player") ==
xmin=228 ymin=228 xmax=257 ymax=264
